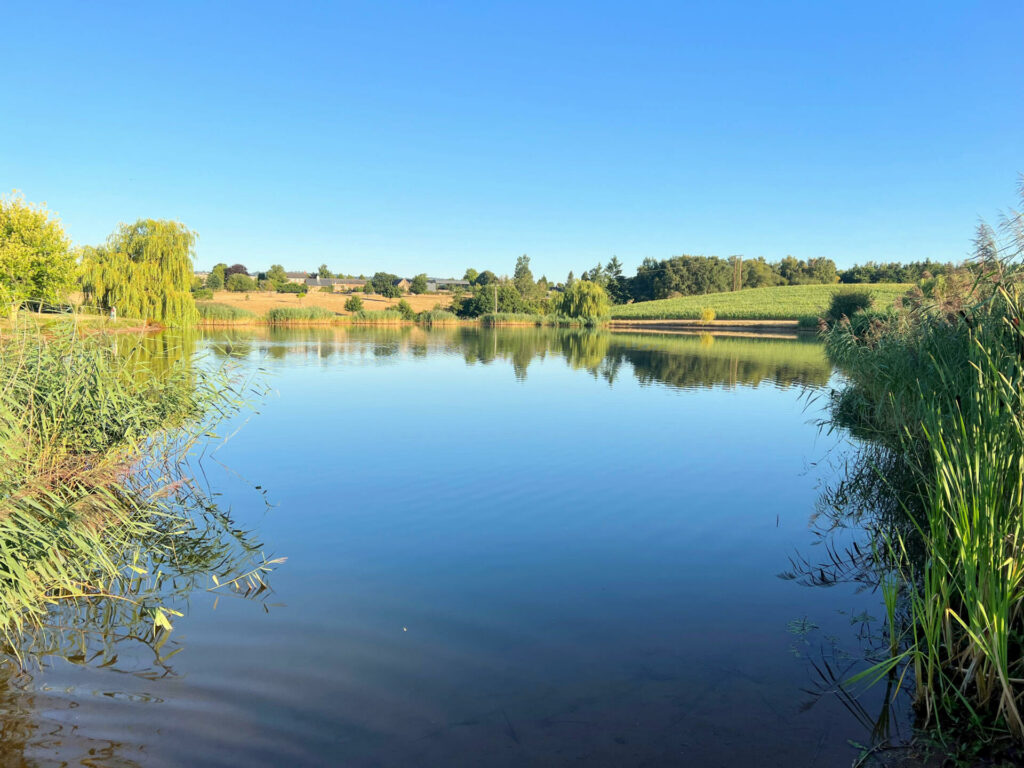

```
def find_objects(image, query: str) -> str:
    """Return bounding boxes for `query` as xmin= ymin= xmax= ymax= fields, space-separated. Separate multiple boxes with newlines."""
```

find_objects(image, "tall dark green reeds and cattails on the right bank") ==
xmin=825 ymin=188 xmax=1024 ymax=749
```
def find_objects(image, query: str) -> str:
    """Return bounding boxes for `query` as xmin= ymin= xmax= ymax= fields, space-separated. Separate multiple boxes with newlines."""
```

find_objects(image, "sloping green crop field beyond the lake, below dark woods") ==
xmin=611 ymin=283 xmax=910 ymax=322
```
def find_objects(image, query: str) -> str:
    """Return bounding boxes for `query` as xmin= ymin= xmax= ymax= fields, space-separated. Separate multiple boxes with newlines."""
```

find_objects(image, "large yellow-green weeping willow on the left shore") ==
xmin=82 ymin=219 xmax=198 ymax=325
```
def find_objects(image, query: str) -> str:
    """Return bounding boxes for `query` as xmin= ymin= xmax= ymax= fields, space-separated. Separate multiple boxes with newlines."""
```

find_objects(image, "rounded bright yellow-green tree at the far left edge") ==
xmin=0 ymin=196 xmax=74 ymax=307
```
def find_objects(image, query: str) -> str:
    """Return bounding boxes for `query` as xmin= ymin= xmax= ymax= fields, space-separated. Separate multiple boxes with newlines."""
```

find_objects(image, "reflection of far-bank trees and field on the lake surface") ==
xmin=195 ymin=326 xmax=831 ymax=389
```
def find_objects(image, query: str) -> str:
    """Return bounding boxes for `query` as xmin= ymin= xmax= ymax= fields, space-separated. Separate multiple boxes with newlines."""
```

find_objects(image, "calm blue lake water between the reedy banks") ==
xmin=0 ymin=328 xmax=878 ymax=766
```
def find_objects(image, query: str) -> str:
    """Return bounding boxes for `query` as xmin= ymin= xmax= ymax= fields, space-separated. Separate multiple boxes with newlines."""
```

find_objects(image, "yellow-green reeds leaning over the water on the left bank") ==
xmin=0 ymin=328 xmax=272 ymax=655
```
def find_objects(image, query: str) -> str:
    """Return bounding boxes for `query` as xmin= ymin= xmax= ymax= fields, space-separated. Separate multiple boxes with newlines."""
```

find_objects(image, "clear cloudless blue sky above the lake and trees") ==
xmin=0 ymin=0 xmax=1024 ymax=280
